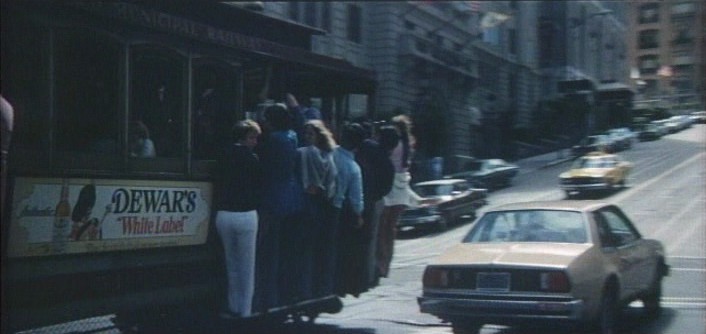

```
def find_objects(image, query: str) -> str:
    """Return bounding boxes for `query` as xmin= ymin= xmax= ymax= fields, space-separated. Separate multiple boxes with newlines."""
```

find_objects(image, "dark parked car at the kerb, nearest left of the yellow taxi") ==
xmin=445 ymin=159 xmax=519 ymax=189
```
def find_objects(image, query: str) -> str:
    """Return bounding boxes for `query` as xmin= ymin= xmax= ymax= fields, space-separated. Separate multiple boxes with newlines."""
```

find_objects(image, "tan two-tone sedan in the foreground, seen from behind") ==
xmin=417 ymin=201 xmax=669 ymax=333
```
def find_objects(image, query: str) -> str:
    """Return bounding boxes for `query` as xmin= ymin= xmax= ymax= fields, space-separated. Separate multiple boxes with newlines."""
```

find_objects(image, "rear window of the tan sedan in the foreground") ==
xmin=463 ymin=210 xmax=588 ymax=243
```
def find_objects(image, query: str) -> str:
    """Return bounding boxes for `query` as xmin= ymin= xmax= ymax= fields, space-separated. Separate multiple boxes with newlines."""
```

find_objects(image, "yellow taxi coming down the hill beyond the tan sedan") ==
xmin=559 ymin=152 xmax=633 ymax=198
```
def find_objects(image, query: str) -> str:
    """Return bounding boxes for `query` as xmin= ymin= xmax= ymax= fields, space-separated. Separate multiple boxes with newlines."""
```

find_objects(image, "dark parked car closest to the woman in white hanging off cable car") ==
xmin=397 ymin=179 xmax=488 ymax=230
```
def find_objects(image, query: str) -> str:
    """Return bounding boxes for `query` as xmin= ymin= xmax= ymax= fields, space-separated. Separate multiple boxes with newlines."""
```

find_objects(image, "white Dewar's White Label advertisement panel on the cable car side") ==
xmin=8 ymin=178 xmax=212 ymax=257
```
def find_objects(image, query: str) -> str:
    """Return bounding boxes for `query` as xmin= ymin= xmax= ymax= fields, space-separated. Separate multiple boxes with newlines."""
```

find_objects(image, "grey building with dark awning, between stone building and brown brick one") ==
xmin=537 ymin=1 xmax=634 ymax=142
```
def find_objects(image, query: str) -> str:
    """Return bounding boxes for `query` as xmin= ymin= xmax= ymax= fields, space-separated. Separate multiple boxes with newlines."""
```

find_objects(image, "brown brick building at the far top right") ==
xmin=629 ymin=1 xmax=706 ymax=112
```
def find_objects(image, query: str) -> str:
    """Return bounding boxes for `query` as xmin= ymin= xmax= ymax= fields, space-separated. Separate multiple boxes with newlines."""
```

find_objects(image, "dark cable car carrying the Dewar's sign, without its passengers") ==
xmin=0 ymin=0 xmax=375 ymax=333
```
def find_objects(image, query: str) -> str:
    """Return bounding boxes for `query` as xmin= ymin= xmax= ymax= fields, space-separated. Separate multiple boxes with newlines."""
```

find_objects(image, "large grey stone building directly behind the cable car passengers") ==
xmin=262 ymin=1 xmax=541 ymax=171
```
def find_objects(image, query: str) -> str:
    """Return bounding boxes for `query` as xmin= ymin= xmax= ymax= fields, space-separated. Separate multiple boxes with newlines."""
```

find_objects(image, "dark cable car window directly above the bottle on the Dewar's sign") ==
xmin=54 ymin=29 xmax=123 ymax=158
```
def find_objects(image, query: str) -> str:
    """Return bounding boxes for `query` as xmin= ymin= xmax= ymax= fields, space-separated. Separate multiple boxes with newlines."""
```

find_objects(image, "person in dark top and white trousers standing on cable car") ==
xmin=215 ymin=120 xmax=262 ymax=318
